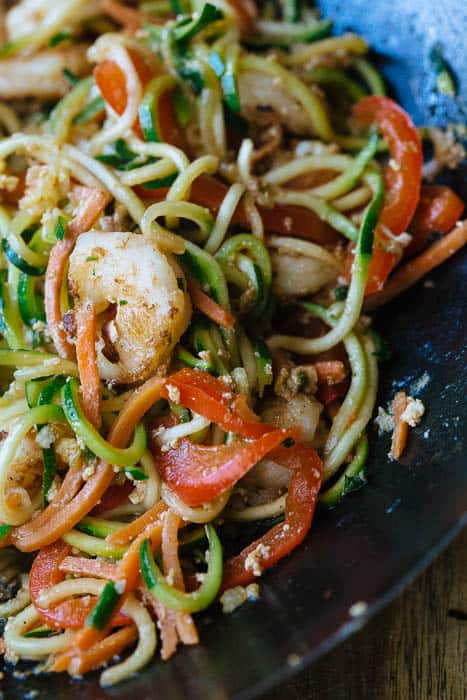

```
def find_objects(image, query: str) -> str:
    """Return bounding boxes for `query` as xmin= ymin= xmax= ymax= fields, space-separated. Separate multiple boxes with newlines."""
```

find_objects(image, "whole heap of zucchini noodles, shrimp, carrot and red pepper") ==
xmin=0 ymin=0 xmax=467 ymax=687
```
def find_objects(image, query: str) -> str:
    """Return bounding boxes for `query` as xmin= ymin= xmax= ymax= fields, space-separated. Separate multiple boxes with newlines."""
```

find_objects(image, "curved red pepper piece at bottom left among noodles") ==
xmin=29 ymin=540 xmax=131 ymax=630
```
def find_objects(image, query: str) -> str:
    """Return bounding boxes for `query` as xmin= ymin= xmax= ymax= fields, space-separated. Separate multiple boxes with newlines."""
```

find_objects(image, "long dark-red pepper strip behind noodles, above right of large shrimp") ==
xmin=135 ymin=175 xmax=340 ymax=244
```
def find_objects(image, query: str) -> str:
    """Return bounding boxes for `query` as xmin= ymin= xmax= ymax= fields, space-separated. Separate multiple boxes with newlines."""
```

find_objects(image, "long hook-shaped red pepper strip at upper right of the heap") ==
xmin=345 ymin=95 xmax=423 ymax=294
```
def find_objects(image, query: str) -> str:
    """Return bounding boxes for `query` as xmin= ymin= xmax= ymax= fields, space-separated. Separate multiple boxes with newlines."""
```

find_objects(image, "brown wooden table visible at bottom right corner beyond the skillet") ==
xmin=262 ymin=530 xmax=467 ymax=700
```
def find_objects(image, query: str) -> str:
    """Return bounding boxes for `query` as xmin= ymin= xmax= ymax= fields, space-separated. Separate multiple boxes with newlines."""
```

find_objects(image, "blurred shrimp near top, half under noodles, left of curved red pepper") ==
xmin=238 ymin=72 xmax=314 ymax=136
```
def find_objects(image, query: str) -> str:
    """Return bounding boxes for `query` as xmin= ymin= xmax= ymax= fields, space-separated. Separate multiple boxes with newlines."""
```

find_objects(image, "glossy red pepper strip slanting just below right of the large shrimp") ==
xmin=161 ymin=367 xmax=275 ymax=438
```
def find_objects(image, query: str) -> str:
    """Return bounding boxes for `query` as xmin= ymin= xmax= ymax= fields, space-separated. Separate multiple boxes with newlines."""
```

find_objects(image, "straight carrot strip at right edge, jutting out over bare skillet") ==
xmin=364 ymin=221 xmax=467 ymax=311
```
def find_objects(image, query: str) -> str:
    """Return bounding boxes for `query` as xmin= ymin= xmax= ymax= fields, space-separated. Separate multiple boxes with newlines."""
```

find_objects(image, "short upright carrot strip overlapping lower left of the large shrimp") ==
xmin=75 ymin=301 xmax=102 ymax=428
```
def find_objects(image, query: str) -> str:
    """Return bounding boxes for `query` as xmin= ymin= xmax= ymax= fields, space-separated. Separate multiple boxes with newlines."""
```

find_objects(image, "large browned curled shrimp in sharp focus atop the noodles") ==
xmin=68 ymin=231 xmax=191 ymax=384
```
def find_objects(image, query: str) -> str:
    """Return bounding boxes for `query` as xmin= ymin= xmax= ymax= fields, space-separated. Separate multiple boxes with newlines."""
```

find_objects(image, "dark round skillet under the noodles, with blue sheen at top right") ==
xmin=2 ymin=0 xmax=467 ymax=700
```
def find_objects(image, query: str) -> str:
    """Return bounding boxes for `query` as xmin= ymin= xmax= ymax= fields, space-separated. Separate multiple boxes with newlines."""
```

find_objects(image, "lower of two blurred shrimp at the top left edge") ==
xmin=0 ymin=45 xmax=89 ymax=100
